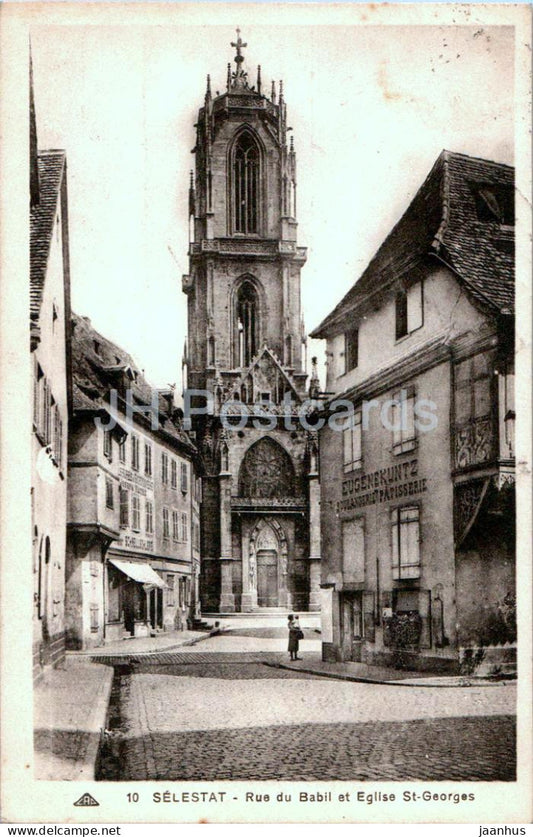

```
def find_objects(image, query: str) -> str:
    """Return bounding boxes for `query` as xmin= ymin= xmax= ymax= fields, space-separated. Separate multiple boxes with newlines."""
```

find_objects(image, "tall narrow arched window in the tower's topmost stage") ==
xmin=232 ymin=131 xmax=260 ymax=235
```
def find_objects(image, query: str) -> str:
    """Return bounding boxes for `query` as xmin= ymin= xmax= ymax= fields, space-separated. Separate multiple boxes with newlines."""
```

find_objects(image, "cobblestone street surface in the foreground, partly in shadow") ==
xmin=96 ymin=640 xmax=515 ymax=781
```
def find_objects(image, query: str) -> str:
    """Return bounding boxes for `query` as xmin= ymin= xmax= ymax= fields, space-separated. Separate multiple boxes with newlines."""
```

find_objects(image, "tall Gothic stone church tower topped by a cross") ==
xmin=183 ymin=30 xmax=320 ymax=613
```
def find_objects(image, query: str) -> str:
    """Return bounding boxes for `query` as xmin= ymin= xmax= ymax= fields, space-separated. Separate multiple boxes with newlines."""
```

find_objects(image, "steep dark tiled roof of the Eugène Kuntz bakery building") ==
xmin=311 ymin=151 xmax=514 ymax=337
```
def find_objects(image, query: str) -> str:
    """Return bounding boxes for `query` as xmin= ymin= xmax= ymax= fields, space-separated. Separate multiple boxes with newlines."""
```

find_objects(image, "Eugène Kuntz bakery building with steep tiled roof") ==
xmin=313 ymin=152 xmax=516 ymax=670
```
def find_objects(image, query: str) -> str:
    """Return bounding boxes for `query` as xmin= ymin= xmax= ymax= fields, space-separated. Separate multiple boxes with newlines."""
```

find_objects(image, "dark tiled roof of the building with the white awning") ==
xmin=72 ymin=313 xmax=196 ymax=455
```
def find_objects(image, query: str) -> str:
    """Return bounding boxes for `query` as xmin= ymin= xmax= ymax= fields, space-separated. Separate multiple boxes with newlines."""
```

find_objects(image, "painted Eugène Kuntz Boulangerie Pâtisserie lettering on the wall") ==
xmin=337 ymin=459 xmax=427 ymax=512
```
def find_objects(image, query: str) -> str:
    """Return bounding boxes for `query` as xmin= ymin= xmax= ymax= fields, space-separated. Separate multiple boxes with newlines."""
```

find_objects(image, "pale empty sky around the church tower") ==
xmin=31 ymin=21 xmax=514 ymax=390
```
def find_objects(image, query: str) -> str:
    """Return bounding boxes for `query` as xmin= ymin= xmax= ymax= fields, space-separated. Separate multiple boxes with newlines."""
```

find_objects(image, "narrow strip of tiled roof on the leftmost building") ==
xmin=30 ymin=151 xmax=66 ymax=321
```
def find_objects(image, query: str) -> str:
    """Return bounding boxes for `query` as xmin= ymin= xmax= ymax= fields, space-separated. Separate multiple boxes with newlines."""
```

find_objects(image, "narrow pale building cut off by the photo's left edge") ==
xmin=30 ymin=62 xmax=70 ymax=677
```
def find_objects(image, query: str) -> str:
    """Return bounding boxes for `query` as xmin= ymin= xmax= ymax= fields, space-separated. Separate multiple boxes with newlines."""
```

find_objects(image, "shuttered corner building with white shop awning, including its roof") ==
xmin=66 ymin=316 xmax=199 ymax=648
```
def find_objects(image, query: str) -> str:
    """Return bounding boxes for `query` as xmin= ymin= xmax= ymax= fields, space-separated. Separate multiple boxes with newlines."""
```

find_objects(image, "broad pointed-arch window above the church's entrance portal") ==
xmin=239 ymin=436 xmax=295 ymax=498
